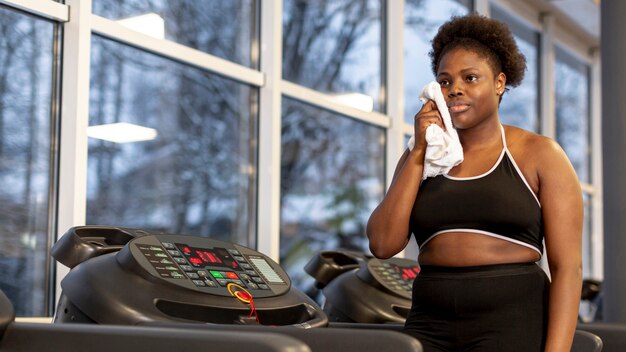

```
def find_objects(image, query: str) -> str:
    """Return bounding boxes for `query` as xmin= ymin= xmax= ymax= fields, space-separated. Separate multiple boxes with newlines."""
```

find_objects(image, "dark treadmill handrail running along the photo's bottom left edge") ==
xmin=0 ymin=290 xmax=311 ymax=352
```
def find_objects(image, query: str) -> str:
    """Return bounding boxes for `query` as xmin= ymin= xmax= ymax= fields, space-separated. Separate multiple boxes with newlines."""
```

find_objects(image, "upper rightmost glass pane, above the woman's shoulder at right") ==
xmin=554 ymin=47 xmax=591 ymax=183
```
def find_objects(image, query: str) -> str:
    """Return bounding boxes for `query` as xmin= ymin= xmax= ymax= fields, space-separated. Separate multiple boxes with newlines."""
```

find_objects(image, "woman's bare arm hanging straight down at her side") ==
xmin=535 ymin=139 xmax=583 ymax=352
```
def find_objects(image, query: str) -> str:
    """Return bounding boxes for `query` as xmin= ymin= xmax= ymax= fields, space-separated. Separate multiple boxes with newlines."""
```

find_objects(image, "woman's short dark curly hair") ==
xmin=428 ymin=13 xmax=526 ymax=87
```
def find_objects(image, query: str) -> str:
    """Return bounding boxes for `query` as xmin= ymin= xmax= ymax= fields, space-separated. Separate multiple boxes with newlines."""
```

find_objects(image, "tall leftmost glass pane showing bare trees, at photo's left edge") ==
xmin=0 ymin=7 xmax=55 ymax=316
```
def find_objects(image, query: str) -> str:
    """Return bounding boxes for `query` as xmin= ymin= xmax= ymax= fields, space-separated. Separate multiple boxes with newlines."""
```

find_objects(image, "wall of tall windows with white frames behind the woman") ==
xmin=0 ymin=0 xmax=602 ymax=316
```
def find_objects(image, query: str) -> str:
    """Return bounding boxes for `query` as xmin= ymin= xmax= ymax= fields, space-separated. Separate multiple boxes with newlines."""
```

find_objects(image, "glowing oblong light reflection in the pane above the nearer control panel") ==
xmin=87 ymin=122 xmax=157 ymax=143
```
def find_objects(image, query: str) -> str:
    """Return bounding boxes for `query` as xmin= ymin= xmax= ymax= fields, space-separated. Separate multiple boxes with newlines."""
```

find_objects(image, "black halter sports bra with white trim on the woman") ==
xmin=410 ymin=127 xmax=544 ymax=255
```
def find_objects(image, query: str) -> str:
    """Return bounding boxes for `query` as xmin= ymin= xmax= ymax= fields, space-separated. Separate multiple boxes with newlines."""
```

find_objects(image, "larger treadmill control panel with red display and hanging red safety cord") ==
xmin=118 ymin=235 xmax=291 ymax=297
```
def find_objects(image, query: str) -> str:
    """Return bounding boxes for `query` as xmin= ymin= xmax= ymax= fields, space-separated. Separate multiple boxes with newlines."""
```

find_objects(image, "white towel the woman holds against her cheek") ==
xmin=407 ymin=81 xmax=463 ymax=180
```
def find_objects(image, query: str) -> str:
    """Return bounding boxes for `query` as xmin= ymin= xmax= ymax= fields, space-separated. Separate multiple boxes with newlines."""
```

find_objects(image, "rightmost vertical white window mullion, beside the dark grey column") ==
xmin=589 ymin=49 xmax=604 ymax=280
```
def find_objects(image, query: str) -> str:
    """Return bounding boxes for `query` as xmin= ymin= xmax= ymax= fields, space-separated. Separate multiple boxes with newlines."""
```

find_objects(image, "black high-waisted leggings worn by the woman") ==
xmin=404 ymin=263 xmax=550 ymax=352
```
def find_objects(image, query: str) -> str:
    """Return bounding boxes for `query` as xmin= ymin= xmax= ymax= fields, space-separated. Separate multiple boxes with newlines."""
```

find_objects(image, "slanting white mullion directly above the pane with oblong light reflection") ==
xmin=91 ymin=15 xmax=264 ymax=87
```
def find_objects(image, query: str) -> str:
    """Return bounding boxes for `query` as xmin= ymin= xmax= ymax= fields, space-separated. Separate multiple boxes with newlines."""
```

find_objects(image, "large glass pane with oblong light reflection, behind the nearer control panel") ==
xmin=87 ymin=36 xmax=258 ymax=246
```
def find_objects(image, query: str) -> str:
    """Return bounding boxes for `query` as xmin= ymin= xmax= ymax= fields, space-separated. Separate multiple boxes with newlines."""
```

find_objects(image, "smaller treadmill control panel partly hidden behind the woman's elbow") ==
xmin=367 ymin=258 xmax=420 ymax=299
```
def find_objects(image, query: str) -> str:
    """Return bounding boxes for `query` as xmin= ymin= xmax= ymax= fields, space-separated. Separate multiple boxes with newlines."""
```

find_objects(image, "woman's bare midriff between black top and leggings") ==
xmin=419 ymin=232 xmax=541 ymax=266
